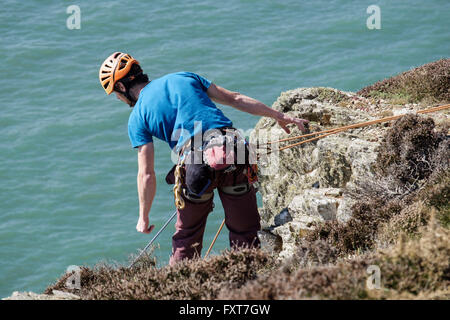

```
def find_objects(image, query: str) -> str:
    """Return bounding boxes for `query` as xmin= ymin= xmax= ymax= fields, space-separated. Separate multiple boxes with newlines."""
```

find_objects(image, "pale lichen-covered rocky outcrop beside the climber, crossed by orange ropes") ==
xmin=251 ymin=88 xmax=448 ymax=259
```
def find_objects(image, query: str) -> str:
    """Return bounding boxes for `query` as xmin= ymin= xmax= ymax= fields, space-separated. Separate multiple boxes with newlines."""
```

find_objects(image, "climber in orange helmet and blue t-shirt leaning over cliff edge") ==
xmin=99 ymin=52 xmax=308 ymax=265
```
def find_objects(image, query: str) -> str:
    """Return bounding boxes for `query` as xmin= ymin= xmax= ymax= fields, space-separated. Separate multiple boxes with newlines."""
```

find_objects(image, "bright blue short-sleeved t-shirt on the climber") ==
xmin=128 ymin=72 xmax=233 ymax=150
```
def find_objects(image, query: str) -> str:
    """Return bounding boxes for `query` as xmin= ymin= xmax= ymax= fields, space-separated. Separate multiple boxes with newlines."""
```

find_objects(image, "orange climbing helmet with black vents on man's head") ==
xmin=98 ymin=52 xmax=139 ymax=94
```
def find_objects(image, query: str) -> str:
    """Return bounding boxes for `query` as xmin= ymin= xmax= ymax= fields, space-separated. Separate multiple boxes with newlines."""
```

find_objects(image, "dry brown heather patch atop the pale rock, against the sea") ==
xmin=358 ymin=59 xmax=450 ymax=104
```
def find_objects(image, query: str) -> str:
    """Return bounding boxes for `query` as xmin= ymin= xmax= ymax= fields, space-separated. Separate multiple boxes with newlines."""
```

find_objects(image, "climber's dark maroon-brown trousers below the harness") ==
xmin=170 ymin=171 xmax=261 ymax=265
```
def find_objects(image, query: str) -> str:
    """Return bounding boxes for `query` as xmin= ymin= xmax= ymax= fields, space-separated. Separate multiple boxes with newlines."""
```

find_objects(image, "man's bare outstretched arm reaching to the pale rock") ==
xmin=207 ymin=83 xmax=309 ymax=133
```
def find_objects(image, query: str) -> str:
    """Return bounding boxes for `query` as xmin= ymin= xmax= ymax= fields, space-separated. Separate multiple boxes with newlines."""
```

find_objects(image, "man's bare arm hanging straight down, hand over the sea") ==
xmin=136 ymin=142 xmax=156 ymax=233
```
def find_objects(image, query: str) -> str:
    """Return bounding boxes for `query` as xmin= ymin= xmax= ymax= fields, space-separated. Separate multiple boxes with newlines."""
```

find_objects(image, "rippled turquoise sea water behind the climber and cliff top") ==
xmin=0 ymin=0 xmax=450 ymax=297
